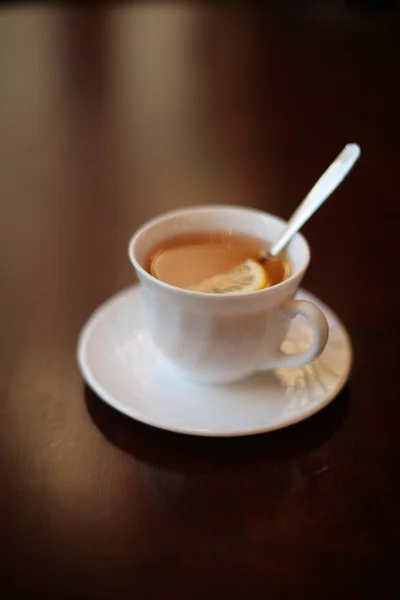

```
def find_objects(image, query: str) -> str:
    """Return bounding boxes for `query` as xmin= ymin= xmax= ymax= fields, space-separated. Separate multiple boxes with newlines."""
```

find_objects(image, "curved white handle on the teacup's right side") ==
xmin=267 ymin=300 xmax=329 ymax=369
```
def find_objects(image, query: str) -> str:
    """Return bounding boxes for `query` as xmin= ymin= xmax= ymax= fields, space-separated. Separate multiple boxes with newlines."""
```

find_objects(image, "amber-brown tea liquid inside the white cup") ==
xmin=144 ymin=231 xmax=291 ymax=289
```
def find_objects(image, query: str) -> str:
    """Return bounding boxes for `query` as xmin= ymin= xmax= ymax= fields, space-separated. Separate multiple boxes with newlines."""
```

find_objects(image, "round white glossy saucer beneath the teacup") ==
xmin=77 ymin=285 xmax=352 ymax=436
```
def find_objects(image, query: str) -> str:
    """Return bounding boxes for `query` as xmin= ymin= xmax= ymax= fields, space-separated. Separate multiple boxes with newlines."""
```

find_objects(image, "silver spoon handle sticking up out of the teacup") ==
xmin=268 ymin=144 xmax=361 ymax=256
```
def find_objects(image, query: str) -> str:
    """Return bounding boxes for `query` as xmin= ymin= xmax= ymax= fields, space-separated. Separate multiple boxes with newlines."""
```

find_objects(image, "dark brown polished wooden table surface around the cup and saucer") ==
xmin=0 ymin=2 xmax=400 ymax=600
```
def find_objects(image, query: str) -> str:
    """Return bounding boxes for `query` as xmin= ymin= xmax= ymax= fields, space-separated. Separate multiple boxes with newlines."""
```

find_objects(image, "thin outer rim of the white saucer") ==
xmin=76 ymin=283 xmax=354 ymax=438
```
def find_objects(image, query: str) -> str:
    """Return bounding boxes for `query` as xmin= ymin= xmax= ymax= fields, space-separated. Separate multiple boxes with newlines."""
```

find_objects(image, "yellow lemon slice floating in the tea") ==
xmin=190 ymin=259 xmax=270 ymax=294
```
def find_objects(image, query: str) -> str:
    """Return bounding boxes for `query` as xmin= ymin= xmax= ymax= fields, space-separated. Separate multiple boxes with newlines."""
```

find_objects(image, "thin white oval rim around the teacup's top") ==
xmin=128 ymin=204 xmax=311 ymax=301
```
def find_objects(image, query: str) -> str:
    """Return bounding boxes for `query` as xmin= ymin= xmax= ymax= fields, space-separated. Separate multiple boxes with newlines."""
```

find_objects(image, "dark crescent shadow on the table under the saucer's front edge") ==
xmin=84 ymin=383 xmax=350 ymax=473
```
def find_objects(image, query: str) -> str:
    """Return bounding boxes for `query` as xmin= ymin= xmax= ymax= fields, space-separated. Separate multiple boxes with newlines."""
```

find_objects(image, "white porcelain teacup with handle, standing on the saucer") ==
xmin=129 ymin=206 xmax=328 ymax=383
